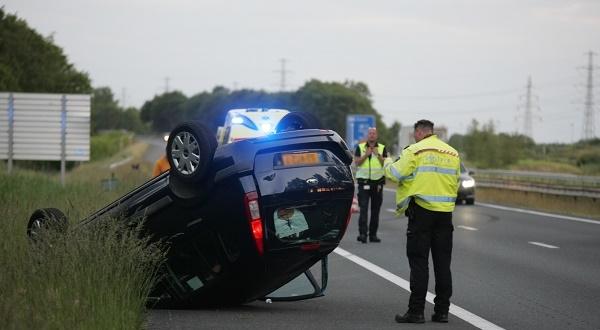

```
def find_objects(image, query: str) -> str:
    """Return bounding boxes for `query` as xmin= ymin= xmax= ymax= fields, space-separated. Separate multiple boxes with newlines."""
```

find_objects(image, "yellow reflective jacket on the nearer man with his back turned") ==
xmin=385 ymin=135 xmax=460 ymax=215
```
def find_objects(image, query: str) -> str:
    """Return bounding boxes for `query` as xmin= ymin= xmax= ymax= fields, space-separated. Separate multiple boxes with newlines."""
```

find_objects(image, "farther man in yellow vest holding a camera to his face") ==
xmin=354 ymin=127 xmax=387 ymax=243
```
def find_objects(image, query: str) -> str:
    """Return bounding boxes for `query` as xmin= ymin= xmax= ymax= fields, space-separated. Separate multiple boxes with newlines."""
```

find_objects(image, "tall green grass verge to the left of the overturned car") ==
xmin=0 ymin=132 xmax=162 ymax=329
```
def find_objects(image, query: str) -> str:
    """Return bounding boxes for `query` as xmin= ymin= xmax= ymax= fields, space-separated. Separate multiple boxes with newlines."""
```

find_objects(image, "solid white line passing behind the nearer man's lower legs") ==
xmin=333 ymin=247 xmax=503 ymax=329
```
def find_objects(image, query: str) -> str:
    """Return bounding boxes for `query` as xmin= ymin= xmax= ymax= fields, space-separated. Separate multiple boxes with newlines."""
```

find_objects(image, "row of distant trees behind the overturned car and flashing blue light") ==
xmin=141 ymin=79 xmax=400 ymax=151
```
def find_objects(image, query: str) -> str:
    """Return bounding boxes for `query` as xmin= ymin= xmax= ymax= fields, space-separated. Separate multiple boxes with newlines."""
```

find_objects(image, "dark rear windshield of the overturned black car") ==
xmin=267 ymin=201 xmax=348 ymax=246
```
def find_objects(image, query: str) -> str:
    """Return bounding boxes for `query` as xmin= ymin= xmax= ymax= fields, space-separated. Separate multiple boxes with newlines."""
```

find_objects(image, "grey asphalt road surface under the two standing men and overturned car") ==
xmin=142 ymin=138 xmax=600 ymax=329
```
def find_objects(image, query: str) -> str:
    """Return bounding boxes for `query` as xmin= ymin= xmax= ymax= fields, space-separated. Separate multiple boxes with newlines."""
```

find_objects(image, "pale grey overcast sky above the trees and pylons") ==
xmin=4 ymin=0 xmax=600 ymax=142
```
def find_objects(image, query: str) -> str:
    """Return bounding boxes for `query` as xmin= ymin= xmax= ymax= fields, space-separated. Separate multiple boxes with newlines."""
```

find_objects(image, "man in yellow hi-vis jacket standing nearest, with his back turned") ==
xmin=385 ymin=120 xmax=460 ymax=323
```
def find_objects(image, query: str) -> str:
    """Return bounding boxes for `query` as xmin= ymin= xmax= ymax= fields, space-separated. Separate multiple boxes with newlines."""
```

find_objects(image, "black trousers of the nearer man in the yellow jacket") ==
xmin=406 ymin=201 xmax=454 ymax=314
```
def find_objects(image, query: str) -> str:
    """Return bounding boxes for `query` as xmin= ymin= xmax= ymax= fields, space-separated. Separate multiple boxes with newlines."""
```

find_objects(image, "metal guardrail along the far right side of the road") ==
xmin=473 ymin=169 xmax=600 ymax=198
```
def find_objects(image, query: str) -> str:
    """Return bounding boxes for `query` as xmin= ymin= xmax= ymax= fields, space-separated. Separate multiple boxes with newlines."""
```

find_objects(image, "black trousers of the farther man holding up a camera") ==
xmin=358 ymin=180 xmax=383 ymax=237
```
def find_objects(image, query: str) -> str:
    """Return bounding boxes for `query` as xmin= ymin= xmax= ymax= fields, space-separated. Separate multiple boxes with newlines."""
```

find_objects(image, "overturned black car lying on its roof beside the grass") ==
xmin=27 ymin=112 xmax=354 ymax=307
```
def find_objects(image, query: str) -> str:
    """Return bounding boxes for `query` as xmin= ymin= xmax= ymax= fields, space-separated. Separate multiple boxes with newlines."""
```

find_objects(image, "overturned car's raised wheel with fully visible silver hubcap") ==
xmin=166 ymin=121 xmax=217 ymax=183
